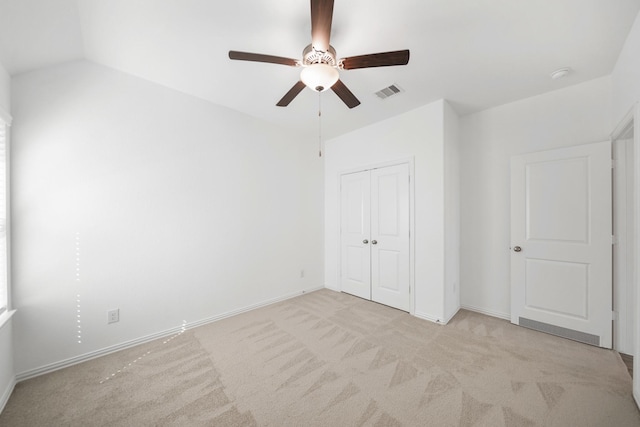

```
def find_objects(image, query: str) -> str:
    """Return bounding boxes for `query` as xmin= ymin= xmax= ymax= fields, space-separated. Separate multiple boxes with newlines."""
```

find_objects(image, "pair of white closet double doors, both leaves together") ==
xmin=340 ymin=164 xmax=411 ymax=311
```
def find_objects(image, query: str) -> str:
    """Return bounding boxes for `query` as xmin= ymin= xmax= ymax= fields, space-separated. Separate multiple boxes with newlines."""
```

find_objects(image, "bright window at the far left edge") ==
xmin=0 ymin=119 xmax=9 ymax=314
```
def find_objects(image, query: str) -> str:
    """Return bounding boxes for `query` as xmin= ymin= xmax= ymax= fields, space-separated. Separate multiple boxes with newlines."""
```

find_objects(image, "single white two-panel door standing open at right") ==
xmin=511 ymin=141 xmax=612 ymax=348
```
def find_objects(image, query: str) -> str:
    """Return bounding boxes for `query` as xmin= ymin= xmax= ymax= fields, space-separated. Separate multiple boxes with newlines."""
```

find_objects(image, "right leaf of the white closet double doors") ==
xmin=371 ymin=163 xmax=410 ymax=311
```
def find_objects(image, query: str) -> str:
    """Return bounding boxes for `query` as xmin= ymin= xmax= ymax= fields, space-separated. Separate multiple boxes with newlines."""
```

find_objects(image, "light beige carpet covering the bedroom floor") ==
xmin=0 ymin=290 xmax=640 ymax=427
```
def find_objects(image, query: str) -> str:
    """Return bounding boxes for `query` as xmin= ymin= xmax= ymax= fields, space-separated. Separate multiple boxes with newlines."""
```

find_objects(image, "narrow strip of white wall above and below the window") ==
xmin=0 ymin=60 xmax=15 ymax=411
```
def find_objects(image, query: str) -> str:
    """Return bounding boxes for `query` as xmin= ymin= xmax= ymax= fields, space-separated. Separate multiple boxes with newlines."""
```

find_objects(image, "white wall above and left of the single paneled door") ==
xmin=460 ymin=77 xmax=611 ymax=319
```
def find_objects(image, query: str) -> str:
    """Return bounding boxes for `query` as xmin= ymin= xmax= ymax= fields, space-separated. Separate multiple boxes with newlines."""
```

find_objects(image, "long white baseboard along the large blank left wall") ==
xmin=14 ymin=286 xmax=324 ymax=384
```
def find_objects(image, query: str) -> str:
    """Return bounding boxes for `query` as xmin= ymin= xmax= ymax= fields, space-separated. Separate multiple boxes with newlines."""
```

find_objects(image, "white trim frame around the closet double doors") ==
xmin=336 ymin=156 xmax=416 ymax=316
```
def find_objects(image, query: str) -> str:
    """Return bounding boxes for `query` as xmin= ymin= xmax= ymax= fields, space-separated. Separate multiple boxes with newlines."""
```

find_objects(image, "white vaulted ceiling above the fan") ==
xmin=0 ymin=0 xmax=640 ymax=137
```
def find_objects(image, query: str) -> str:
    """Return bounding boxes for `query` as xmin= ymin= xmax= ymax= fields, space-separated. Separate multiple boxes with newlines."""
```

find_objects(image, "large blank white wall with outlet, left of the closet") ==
xmin=12 ymin=62 xmax=323 ymax=379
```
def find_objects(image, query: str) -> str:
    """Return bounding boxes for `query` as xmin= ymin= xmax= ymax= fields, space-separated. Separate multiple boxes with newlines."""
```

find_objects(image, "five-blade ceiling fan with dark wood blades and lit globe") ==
xmin=229 ymin=0 xmax=409 ymax=108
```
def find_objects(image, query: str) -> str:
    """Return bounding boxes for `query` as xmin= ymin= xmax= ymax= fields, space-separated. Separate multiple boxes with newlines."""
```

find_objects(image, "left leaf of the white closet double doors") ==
xmin=340 ymin=171 xmax=371 ymax=299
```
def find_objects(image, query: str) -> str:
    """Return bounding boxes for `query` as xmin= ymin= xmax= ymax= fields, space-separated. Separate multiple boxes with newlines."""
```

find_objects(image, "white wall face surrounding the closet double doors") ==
xmin=325 ymin=100 xmax=455 ymax=322
